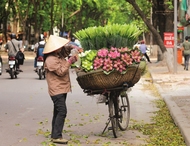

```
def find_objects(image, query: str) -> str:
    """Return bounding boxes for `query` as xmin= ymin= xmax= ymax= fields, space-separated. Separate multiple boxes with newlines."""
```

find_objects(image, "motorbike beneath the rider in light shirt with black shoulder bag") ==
xmin=6 ymin=56 xmax=19 ymax=79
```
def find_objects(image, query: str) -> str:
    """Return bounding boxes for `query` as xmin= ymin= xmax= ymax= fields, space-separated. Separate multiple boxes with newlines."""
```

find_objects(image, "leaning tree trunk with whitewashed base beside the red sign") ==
xmin=126 ymin=0 xmax=174 ymax=72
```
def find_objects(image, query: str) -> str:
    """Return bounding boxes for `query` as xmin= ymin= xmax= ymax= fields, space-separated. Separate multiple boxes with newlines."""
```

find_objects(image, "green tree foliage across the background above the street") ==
xmin=0 ymin=0 xmax=150 ymax=44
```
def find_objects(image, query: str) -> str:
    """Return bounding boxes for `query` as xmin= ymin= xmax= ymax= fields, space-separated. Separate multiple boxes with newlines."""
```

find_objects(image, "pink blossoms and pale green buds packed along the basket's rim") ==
xmin=78 ymin=47 xmax=142 ymax=74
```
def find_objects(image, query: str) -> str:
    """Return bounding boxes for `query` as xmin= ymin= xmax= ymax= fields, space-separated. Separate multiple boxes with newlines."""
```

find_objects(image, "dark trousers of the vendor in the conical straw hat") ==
xmin=51 ymin=94 xmax=67 ymax=139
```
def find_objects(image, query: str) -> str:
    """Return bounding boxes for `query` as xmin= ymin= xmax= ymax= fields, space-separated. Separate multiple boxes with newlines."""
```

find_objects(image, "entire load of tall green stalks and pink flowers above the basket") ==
xmin=74 ymin=24 xmax=145 ymax=74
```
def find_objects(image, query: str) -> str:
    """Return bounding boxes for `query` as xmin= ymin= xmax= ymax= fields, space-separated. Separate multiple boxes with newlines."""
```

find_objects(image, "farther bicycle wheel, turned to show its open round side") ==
xmin=118 ymin=94 xmax=130 ymax=131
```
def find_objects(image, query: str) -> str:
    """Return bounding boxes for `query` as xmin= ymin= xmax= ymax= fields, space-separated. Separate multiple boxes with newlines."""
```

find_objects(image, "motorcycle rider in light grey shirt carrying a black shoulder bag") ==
xmin=5 ymin=33 xmax=22 ymax=72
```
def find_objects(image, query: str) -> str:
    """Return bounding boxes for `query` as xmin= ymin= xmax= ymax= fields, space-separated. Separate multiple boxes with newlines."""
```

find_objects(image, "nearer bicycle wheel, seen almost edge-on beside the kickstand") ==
xmin=108 ymin=93 xmax=118 ymax=138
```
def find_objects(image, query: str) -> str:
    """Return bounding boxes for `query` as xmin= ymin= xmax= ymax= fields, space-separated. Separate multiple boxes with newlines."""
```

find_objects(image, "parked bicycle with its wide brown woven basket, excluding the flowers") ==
xmin=76 ymin=65 xmax=141 ymax=138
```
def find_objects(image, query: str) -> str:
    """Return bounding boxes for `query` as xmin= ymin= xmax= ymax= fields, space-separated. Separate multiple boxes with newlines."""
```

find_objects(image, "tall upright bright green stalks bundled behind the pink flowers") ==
xmin=74 ymin=24 xmax=142 ymax=50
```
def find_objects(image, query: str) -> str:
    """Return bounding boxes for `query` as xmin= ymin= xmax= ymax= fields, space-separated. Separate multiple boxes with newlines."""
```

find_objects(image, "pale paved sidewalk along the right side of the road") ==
xmin=148 ymin=57 xmax=190 ymax=146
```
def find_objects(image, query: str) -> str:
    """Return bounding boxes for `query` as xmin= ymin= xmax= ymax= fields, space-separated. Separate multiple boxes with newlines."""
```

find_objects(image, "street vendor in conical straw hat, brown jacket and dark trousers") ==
xmin=43 ymin=35 xmax=80 ymax=144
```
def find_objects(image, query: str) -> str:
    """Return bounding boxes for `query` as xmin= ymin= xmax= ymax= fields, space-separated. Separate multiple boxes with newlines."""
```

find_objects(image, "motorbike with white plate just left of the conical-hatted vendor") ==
xmin=36 ymin=56 xmax=45 ymax=80
